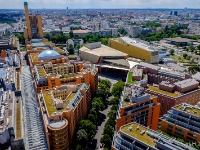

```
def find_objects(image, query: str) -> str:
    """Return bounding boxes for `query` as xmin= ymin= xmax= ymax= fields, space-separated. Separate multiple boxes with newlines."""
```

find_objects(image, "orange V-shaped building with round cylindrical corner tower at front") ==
xmin=38 ymin=84 xmax=91 ymax=150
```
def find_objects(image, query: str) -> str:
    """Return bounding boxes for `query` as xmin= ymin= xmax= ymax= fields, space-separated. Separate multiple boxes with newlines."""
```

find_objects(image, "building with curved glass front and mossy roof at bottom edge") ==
xmin=112 ymin=122 xmax=195 ymax=150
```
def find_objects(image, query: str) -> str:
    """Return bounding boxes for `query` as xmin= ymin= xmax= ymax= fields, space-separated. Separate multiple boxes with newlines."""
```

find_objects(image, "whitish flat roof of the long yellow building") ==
xmin=115 ymin=37 xmax=158 ymax=52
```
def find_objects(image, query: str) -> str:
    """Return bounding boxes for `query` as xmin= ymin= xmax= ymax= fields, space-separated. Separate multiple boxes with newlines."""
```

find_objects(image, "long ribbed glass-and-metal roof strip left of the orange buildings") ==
xmin=21 ymin=66 xmax=48 ymax=150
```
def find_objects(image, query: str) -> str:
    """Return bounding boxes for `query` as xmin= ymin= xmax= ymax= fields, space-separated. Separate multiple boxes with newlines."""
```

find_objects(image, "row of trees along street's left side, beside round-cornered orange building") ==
xmin=76 ymin=80 xmax=111 ymax=150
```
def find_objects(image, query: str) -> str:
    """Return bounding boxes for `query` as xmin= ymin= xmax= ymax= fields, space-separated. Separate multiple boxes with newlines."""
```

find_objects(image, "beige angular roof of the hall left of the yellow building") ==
xmin=80 ymin=44 xmax=128 ymax=57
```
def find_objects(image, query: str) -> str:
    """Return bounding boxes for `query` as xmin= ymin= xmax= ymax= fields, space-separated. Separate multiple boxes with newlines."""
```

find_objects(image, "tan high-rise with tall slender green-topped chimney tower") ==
xmin=24 ymin=2 xmax=43 ymax=39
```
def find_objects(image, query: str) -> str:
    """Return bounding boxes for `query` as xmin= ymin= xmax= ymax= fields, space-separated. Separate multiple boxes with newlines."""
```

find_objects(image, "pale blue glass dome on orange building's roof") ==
xmin=38 ymin=49 xmax=62 ymax=60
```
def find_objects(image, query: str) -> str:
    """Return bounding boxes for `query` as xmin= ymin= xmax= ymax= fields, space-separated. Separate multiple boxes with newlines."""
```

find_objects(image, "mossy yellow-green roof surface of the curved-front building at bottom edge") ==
xmin=121 ymin=123 xmax=157 ymax=147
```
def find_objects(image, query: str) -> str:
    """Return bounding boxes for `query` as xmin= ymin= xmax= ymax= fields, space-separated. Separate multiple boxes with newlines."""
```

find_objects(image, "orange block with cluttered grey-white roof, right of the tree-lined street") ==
xmin=116 ymin=85 xmax=160 ymax=131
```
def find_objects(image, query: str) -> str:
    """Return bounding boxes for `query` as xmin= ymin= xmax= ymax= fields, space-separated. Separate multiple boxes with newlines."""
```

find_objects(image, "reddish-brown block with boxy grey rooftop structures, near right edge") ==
xmin=132 ymin=62 xmax=200 ymax=117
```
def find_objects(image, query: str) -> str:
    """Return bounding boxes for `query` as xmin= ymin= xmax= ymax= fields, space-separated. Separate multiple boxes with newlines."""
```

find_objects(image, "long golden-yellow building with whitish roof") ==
xmin=109 ymin=37 xmax=159 ymax=63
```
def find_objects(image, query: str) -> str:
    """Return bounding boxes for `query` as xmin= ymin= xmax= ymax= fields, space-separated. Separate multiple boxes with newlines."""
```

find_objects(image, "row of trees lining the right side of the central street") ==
xmin=100 ymin=81 xmax=124 ymax=150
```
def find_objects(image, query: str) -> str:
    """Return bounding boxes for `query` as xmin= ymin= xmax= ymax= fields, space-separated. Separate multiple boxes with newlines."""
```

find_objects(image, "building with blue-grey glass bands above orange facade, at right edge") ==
xmin=159 ymin=103 xmax=200 ymax=143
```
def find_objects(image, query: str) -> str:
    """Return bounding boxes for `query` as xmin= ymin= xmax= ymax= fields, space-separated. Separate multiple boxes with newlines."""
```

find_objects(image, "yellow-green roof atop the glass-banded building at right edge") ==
xmin=173 ymin=103 xmax=200 ymax=117
